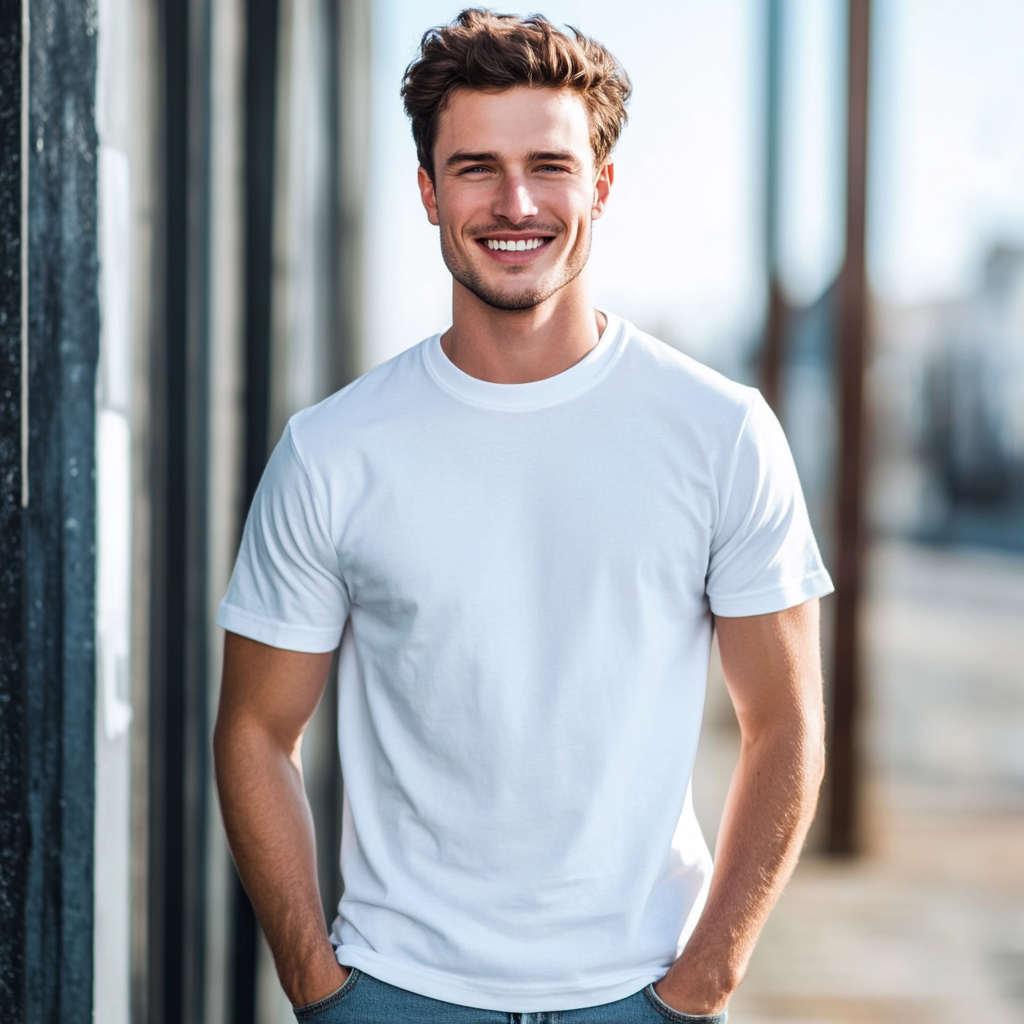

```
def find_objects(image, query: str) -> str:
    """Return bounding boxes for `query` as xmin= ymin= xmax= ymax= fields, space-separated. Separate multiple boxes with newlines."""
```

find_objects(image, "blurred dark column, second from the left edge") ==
xmin=147 ymin=0 xmax=210 ymax=1024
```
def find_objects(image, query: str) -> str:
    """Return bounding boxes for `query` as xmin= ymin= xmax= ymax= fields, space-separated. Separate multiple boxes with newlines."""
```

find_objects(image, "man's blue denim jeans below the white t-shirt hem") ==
xmin=295 ymin=968 xmax=727 ymax=1024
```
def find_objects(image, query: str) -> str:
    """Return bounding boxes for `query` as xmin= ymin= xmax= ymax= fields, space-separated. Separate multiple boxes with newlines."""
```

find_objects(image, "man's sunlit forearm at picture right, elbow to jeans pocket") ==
xmin=658 ymin=720 xmax=823 ymax=1013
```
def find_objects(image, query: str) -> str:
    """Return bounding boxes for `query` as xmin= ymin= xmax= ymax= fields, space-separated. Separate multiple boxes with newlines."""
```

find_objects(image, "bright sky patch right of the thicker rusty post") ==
xmin=869 ymin=0 xmax=1024 ymax=302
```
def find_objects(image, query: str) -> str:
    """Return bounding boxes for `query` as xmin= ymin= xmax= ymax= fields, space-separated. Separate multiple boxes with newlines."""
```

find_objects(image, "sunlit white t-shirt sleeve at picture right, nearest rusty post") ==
xmin=707 ymin=394 xmax=833 ymax=616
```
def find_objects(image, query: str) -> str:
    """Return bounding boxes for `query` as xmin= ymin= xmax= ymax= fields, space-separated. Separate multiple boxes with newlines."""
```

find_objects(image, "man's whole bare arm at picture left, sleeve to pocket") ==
xmin=213 ymin=633 xmax=347 ymax=1007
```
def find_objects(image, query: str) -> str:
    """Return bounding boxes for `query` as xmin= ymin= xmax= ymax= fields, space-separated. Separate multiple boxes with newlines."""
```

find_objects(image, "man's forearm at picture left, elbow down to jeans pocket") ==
xmin=214 ymin=719 xmax=345 ymax=1006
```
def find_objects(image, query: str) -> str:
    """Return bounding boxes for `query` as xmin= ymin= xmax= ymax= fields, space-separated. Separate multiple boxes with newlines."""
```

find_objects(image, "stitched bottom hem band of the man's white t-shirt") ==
xmin=335 ymin=945 xmax=665 ymax=1014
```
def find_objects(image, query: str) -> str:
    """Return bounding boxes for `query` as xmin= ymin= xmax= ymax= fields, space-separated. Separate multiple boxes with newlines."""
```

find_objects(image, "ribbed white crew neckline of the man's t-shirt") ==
xmin=423 ymin=309 xmax=626 ymax=411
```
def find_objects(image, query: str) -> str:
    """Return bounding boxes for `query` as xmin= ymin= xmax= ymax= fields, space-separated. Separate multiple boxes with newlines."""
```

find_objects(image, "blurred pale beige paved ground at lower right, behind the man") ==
xmin=695 ymin=544 xmax=1024 ymax=1024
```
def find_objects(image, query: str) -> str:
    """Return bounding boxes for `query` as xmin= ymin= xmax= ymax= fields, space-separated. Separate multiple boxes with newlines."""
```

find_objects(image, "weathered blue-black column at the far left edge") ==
xmin=0 ymin=0 xmax=99 ymax=1021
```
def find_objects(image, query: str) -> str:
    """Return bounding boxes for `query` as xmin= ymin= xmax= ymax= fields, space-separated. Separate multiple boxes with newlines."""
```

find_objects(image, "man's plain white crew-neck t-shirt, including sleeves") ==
xmin=218 ymin=315 xmax=831 ymax=1012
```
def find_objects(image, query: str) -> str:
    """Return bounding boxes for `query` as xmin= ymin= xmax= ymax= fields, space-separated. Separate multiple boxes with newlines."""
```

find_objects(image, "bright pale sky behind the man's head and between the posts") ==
xmin=368 ymin=0 xmax=1024 ymax=370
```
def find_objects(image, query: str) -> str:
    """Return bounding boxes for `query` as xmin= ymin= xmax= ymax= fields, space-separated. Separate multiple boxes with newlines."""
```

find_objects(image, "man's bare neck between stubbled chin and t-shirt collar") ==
xmin=441 ymin=271 xmax=607 ymax=384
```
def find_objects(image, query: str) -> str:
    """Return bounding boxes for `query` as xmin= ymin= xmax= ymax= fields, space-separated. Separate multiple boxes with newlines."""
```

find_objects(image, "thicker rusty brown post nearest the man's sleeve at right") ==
xmin=826 ymin=0 xmax=870 ymax=855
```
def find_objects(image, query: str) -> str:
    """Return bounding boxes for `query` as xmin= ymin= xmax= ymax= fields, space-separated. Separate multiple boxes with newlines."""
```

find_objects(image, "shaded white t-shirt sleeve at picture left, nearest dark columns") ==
xmin=217 ymin=426 xmax=349 ymax=654
